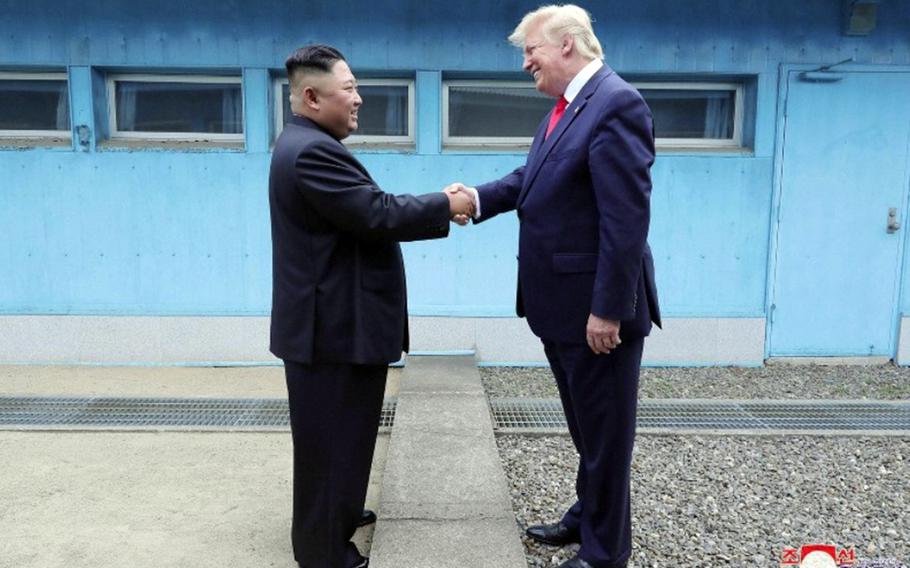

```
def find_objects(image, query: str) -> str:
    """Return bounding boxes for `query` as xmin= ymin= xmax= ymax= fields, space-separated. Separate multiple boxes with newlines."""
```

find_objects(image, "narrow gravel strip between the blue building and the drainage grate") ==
xmin=480 ymin=364 xmax=910 ymax=400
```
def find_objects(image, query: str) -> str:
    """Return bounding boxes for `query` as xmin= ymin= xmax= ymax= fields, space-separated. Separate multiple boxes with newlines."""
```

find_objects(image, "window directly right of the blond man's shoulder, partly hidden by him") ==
xmin=635 ymin=83 xmax=743 ymax=148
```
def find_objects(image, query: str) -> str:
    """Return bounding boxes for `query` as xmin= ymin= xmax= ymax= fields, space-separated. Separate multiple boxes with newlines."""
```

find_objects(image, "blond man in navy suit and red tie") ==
xmin=453 ymin=5 xmax=660 ymax=568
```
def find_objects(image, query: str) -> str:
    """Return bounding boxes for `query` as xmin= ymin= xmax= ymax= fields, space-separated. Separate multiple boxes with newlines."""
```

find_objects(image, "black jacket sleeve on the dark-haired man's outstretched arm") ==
xmin=295 ymin=141 xmax=449 ymax=241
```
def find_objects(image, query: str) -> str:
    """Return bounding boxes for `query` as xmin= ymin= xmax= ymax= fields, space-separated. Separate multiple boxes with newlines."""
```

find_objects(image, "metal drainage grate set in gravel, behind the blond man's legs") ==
xmin=490 ymin=399 xmax=910 ymax=432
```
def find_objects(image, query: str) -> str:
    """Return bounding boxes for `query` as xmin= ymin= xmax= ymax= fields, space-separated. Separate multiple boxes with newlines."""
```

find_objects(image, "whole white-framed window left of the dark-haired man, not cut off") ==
xmin=108 ymin=75 xmax=243 ymax=143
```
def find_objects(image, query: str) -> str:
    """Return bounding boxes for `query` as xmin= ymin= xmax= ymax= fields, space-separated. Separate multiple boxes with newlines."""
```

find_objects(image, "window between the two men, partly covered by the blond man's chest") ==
xmin=442 ymin=81 xmax=553 ymax=148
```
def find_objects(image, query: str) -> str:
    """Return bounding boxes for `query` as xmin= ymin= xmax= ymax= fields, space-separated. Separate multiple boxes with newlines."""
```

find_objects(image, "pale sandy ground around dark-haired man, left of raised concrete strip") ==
xmin=0 ymin=366 xmax=392 ymax=568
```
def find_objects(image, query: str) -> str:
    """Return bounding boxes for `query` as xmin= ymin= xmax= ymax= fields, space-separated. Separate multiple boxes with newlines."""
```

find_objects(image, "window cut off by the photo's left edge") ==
xmin=0 ymin=73 xmax=70 ymax=139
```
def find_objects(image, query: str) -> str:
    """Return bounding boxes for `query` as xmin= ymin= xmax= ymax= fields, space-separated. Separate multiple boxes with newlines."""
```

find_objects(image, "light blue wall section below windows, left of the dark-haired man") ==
xmin=0 ymin=152 xmax=270 ymax=315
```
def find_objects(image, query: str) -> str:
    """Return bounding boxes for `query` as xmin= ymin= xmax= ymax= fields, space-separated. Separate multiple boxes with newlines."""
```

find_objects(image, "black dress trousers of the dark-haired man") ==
xmin=284 ymin=360 xmax=388 ymax=568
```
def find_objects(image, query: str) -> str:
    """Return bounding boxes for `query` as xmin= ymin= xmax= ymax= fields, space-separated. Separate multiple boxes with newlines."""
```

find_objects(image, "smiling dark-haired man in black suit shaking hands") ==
xmin=269 ymin=45 xmax=473 ymax=568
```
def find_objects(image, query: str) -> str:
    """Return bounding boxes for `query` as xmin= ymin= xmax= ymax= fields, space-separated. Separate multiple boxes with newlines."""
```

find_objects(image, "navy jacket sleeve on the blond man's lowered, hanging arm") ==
xmin=588 ymin=89 xmax=654 ymax=320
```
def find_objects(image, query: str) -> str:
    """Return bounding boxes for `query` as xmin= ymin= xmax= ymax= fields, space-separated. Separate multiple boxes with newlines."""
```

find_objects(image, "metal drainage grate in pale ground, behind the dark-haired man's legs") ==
xmin=0 ymin=397 xmax=397 ymax=430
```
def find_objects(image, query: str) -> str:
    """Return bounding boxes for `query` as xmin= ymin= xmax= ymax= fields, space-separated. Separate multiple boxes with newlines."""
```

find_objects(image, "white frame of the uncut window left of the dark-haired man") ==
xmin=105 ymin=73 xmax=247 ymax=144
